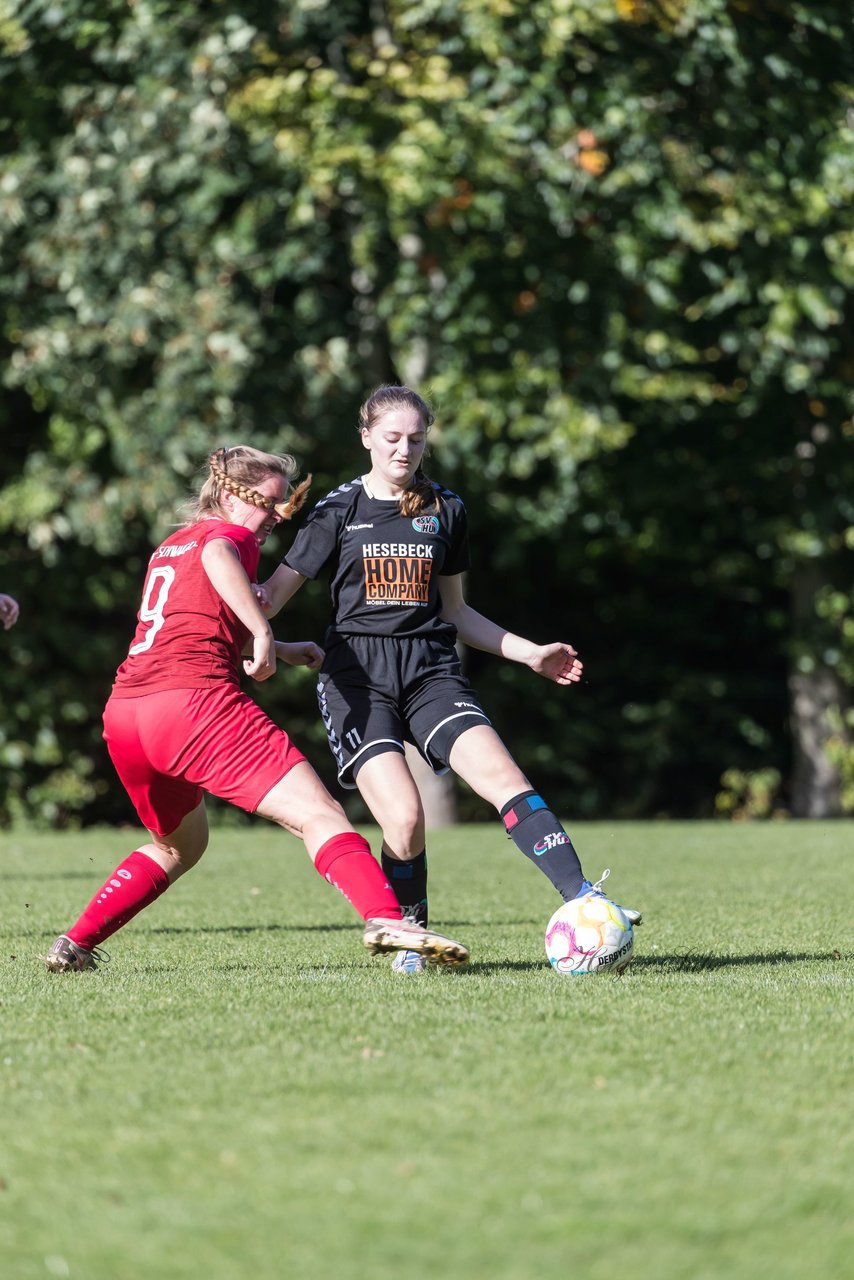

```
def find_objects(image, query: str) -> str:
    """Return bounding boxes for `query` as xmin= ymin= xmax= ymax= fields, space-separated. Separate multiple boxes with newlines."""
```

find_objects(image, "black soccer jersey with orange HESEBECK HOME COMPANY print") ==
xmin=283 ymin=477 xmax=469 ymax=636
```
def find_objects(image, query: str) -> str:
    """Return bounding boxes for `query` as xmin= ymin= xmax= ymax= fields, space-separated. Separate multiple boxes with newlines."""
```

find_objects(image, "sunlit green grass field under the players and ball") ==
xmin=0 ymin=822 xmax=854 ymax=1280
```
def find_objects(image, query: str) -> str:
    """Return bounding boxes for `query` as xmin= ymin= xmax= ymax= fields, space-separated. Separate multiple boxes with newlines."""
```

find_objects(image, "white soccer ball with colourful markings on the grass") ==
xmin=545 ymin=893 xmax=635 ymax=977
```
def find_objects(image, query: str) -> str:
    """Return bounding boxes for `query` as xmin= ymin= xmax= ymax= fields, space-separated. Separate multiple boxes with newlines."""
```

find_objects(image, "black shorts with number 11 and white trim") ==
xmin=318 ymin=635 xmax=489 ymax=790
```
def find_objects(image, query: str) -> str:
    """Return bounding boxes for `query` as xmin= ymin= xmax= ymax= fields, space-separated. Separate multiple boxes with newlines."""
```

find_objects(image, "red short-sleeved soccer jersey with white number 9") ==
xmin=113 ymin=520 xmax=261 ymax=698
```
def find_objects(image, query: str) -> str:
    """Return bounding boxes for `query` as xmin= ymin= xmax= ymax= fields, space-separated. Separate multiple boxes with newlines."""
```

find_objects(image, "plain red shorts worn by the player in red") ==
xmin=104 ymin=682 xmax=305 ymax=836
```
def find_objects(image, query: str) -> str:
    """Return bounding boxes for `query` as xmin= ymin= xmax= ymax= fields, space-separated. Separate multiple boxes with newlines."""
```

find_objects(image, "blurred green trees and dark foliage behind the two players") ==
xmin=0 ymin=0 xmax=854 ymax=826
